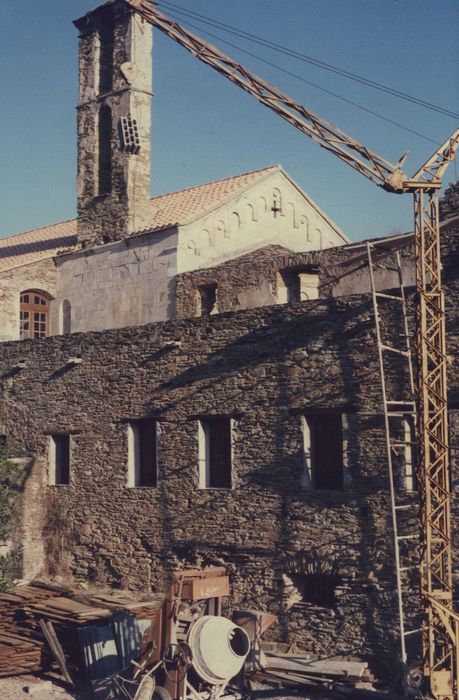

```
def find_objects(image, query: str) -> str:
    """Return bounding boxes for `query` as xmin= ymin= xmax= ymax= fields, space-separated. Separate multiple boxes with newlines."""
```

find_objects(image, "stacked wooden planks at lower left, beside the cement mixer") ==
xmin=0 ymin=581 xmax=163 ymax=677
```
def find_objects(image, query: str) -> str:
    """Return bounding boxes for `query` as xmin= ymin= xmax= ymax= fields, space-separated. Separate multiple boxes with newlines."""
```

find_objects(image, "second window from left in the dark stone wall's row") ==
xmin=128 ymin=418 xmax=158 ymax=488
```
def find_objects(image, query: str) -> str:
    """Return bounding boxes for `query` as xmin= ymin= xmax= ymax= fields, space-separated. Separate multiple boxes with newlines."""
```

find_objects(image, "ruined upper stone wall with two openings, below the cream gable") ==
xmin=176 ymin=235 xmax=415 ymax=318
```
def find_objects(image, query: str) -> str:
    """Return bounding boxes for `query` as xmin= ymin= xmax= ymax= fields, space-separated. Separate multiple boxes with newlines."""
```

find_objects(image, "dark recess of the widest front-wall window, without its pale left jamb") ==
xmin=308 ymin=413 xmax=343 ymax=490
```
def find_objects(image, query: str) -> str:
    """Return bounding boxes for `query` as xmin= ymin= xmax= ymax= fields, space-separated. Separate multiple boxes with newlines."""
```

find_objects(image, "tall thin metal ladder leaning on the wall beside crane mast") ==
xmin=367 ymin=242 xmax=421 ymax=691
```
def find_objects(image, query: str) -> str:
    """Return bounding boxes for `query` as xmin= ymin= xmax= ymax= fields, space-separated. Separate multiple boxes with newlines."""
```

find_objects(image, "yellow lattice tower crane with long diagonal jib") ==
xmin=124 ymin=0 xmax=459 ymax=700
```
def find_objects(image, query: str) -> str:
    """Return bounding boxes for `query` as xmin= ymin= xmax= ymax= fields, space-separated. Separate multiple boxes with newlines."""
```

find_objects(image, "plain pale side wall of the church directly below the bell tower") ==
xmin=52 ymin=229 xmax=177 ymax=333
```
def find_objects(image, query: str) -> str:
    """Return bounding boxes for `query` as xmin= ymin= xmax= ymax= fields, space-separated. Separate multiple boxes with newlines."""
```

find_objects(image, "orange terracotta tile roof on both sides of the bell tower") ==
xmin=0 ymin=165 xmax=279 ymax=270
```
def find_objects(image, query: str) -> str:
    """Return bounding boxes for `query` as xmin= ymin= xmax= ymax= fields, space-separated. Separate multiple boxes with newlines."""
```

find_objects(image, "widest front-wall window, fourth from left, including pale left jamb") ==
xmin=302 ymin=413 xmax=344 ymax=491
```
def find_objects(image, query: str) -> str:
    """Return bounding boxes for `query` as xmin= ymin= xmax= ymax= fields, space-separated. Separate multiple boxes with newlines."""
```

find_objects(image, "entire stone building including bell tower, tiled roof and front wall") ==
xmin=0 ymin=0 xmax=459 ymax=672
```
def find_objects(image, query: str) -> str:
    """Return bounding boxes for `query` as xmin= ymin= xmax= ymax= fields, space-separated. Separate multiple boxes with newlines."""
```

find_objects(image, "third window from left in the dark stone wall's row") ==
xmin=198 ymin=417 xmax=233 ymax=489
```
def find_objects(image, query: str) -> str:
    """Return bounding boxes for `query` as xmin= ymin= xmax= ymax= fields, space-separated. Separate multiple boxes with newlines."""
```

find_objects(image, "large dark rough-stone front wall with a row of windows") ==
xmin=0 ymin=223 xmax=459 ymax=659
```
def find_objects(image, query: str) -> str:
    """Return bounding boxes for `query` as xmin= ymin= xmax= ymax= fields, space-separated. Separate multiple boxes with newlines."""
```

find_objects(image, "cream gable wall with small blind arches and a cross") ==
xmin=177 ymin=171 xmax=349 ymax=272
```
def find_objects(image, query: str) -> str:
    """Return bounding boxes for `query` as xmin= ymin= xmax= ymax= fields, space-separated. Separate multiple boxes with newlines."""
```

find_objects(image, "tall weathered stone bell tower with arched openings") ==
xmin=74 ymin=0 xmax=152 ymax=247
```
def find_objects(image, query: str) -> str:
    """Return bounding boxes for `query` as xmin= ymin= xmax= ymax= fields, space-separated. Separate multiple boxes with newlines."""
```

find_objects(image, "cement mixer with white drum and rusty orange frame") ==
xmin=136 ymin=567 xmax=250 ymax=700
